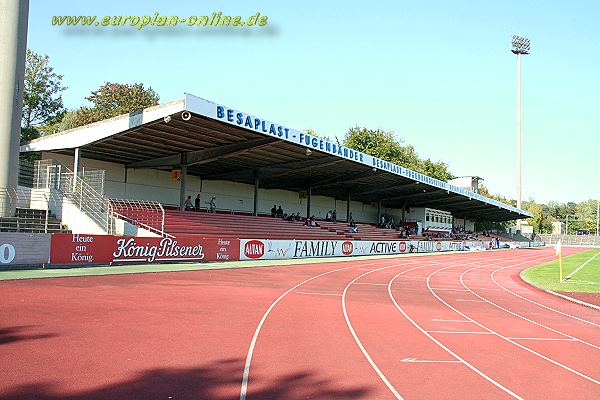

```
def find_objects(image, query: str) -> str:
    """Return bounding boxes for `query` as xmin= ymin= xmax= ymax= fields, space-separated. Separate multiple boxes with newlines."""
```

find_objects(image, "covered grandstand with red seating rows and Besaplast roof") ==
xmin=4 ymin=94 xmax=530 ymax=248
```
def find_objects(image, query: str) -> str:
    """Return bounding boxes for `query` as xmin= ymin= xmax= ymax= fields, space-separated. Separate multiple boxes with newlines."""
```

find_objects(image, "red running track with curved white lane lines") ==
xmin=0 ymin=249 xmax=600 ymax=400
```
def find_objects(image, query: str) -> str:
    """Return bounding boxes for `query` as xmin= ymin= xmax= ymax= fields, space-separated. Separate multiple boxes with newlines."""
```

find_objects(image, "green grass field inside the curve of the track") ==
xmin=521 ymin=250 xmax=600 ymax=293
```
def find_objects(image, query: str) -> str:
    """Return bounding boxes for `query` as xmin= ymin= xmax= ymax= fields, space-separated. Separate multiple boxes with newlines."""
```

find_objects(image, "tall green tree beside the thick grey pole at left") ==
xmin=21 ymin=49 xmax=66 ymax=142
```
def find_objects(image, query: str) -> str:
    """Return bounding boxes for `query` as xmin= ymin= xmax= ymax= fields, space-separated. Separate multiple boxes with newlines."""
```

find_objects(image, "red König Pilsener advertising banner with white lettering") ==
xmin=50 ymin=234 xmax=239 ymax=264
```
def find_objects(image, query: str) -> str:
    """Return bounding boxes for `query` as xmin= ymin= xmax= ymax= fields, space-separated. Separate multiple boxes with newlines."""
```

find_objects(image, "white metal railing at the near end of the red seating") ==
xmin=109 ymin=199 xmax=174 ymax=237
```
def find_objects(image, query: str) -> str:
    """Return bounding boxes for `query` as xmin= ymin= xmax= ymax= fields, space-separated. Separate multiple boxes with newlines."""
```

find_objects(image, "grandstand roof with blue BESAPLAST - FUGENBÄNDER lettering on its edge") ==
xmin=21 ymin=94 xmax=531 ymax=221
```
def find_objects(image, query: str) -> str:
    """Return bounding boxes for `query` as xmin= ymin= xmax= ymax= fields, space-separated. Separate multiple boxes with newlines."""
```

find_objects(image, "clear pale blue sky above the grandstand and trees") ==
xmin=29 ymin=0 xmax=600 ymax=202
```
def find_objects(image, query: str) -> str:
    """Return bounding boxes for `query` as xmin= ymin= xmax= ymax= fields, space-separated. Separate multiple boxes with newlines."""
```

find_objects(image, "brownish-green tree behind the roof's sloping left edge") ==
xmin=74 ymin=82 xmax=160 ymax=126
